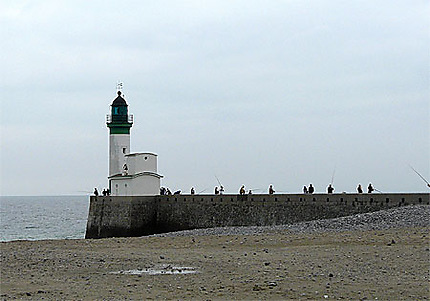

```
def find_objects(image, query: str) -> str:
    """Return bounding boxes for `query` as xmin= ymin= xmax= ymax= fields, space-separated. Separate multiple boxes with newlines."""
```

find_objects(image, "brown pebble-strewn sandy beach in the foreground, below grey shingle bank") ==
xmin=1 ymin=227 xmax=430 ymax=300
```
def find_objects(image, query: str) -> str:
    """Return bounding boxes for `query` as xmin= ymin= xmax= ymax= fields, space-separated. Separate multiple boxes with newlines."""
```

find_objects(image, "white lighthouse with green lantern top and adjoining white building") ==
xmin=106 ymin=87 xmax=163 ymax=196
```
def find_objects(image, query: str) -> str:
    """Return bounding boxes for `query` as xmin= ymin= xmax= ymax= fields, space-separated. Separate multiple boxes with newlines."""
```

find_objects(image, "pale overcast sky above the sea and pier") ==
xmin=0 ymin=0 xmax=430 ymax=195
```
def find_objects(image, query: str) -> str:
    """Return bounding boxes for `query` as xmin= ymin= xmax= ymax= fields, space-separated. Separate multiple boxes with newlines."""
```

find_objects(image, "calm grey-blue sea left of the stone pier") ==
xmin=0 ymin=196 xmax=89 ymax=241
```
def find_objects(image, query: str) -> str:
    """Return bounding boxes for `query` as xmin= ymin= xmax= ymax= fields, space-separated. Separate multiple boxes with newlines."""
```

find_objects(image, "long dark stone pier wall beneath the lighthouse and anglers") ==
xmin=85 ymin=193 xmax=430 ymax=238
